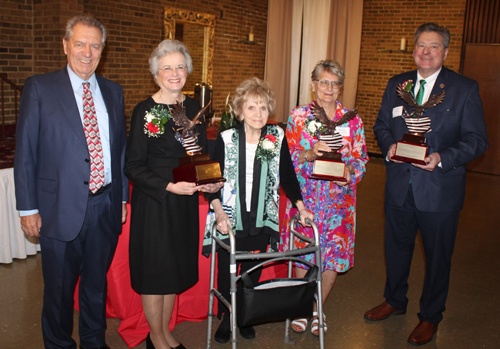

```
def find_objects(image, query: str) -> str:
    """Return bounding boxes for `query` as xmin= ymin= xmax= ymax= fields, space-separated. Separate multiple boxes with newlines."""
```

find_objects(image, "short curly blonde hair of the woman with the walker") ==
xmin=233 ymin=77 xmax=276 ymax=120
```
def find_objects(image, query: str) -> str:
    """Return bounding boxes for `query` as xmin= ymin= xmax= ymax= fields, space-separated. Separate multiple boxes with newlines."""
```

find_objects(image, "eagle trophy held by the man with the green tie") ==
xmin=392 ymin=84 xmax=446 ymax=165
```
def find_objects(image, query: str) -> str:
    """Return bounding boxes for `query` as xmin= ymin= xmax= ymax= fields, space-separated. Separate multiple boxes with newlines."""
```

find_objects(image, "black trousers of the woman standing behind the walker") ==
xmin=217 ymin=234 xmax=269 ymax=317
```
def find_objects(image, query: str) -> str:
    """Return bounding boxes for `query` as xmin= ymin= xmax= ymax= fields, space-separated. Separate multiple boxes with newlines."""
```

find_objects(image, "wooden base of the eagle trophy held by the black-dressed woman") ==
xmin=173 ymin=154 xmax=226 ymax=185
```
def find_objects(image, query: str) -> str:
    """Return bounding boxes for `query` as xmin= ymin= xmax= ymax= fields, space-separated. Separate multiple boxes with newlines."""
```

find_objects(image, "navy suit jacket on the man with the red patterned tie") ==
xmin=14 ymin=67 xmax=129 ymax=241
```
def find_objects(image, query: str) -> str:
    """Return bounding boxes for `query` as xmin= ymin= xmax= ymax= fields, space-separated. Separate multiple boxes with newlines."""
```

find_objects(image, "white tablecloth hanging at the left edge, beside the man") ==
xmin=0 ymin=168 xmax=40 ymax=263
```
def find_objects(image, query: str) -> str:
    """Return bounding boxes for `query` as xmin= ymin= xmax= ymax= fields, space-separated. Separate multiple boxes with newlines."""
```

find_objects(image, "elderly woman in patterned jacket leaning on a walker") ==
xmin=204 ymin=78 xmax=313 ymax=343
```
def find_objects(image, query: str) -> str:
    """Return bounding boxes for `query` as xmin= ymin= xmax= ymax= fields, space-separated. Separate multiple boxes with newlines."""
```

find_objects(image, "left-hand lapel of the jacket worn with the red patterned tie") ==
xmin=54 ymin=67 xmax=87 ymax=146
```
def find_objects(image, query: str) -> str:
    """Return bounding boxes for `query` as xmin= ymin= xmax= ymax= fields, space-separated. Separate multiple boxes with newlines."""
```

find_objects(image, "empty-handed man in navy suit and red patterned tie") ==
xmin=14 ymin=15 xmax=128 ymax=348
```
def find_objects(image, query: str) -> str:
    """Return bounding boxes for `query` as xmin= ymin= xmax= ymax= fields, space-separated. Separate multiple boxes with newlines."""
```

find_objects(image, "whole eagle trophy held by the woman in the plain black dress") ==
xmin=172 ymin=102 xmax=226 ymax=185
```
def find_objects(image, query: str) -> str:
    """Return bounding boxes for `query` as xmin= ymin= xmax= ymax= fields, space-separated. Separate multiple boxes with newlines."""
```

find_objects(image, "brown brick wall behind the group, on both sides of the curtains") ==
xmin=0 ymin=0 xmax=466 ymax=144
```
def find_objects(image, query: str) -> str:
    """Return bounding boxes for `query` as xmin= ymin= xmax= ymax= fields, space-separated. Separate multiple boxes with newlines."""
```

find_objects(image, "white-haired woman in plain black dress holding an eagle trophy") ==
xmin=124 ymin=40 xmax=220 ymax=349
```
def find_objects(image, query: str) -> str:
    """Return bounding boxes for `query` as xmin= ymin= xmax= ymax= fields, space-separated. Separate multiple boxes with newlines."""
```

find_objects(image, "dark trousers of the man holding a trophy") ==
xmin=384 ymin=186 xmax=459 ymax=324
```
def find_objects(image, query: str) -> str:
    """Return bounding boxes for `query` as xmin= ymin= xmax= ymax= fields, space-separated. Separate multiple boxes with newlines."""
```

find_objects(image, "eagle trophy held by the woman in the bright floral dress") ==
xmin=310 ymin=101 xmax=358 ymax=182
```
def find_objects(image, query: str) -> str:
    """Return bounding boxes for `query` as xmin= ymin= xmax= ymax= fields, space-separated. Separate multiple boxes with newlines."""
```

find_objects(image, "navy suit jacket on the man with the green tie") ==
xmin=373 ymin=67 xmax=488 ymax=212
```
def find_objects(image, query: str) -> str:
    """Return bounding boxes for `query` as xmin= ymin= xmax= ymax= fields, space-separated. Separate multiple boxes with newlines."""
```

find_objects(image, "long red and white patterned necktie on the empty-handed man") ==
xmin=83 ymin=82 xmax=104 ymax=193
